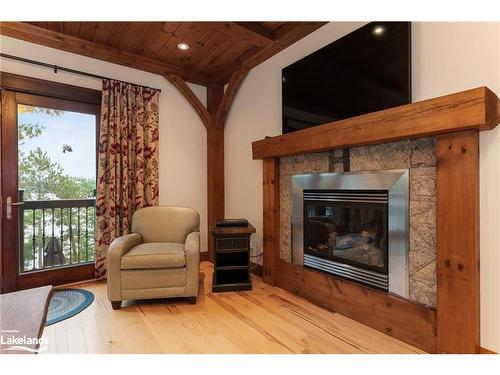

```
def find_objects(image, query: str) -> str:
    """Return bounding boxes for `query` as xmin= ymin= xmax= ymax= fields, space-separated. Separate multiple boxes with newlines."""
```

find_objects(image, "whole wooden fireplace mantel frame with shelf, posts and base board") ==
xmin=252 ymin=87 xmax=500 ymax=353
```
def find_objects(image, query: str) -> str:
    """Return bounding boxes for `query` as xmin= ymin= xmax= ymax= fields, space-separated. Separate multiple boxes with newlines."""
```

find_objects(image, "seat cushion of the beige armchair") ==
xmin=121 ymin=242 xmax=186 ymax=270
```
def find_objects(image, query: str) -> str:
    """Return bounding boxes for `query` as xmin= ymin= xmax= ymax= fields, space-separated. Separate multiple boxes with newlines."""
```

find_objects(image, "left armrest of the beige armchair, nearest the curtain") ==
xmin=106 ymin=233 xmax=142 ymax=301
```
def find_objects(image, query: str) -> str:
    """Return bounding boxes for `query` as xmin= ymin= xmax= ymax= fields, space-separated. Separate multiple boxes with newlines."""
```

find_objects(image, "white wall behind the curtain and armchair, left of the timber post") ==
xmin=0 ymin=36 xmax=207 ymax=251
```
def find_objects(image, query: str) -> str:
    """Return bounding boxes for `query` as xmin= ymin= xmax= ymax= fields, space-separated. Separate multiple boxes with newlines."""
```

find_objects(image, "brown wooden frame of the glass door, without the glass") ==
xmin=0 ymin=72 xmax=101 ymax=292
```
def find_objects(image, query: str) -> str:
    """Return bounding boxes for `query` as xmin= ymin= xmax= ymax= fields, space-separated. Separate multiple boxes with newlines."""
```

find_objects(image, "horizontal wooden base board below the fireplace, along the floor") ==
xmin=278 ymin=258 xmax=436 ymax=353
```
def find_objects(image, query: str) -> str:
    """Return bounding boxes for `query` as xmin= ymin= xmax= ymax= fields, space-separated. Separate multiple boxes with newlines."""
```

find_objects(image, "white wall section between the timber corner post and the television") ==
xmin=224 ymin=22 xmax=364 ymax=254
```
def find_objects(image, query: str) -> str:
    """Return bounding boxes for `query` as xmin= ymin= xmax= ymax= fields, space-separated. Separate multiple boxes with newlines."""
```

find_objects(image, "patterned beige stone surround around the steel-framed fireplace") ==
xmin=279 ymin=137 xmax=437 ymax=308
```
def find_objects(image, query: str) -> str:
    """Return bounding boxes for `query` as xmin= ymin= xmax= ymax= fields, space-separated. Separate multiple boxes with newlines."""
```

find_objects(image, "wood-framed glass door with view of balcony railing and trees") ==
xmin=2 ymin=72 xmax=99 ymax=291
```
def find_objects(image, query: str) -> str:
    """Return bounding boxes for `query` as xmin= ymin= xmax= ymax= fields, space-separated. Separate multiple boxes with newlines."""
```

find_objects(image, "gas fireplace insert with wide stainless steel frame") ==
xmin=292 ymin=170 xmax=409 ymax=297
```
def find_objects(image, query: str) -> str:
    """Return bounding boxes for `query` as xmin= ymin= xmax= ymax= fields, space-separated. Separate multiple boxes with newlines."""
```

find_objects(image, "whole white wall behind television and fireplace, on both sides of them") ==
xmin=225 ymin=23 xmax=500 ymax=352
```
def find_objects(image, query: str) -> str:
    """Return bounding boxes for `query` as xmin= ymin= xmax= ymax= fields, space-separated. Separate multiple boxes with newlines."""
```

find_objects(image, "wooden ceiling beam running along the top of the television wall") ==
xmin=212 ymin=22 xmax=327 ymax=83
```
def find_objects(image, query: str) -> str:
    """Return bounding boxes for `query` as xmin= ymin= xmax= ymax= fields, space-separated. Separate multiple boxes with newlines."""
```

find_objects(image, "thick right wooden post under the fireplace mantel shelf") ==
xmin=436 ymin=130 xmax=480 ymax=353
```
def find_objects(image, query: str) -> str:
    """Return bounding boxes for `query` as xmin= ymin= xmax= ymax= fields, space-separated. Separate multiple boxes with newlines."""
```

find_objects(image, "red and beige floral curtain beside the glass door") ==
xmin=95 ymin=80 xmax=159 ymax=278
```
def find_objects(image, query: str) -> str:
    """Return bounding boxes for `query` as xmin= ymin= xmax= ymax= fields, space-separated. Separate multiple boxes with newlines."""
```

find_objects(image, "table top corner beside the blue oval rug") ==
xmin=0 ymin=285 xmax=53 ymax=354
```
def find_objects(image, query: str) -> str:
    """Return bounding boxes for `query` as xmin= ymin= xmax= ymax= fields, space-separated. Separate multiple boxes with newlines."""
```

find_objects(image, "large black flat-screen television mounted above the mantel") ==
xmin=282 ymin=22 xmax=411 ymax=133
